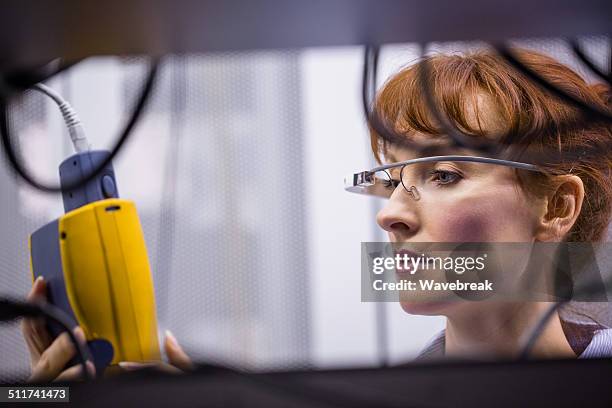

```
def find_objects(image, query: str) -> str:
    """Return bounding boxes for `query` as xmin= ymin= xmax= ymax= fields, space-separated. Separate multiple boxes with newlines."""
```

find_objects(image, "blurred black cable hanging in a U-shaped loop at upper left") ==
xmin=0 ymin=59 xmax=159 ymax=193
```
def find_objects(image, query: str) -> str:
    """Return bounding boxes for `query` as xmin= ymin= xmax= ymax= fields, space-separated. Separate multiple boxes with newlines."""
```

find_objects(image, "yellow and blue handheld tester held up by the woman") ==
xmin=30 ymin=151 xmax=161 ymax=374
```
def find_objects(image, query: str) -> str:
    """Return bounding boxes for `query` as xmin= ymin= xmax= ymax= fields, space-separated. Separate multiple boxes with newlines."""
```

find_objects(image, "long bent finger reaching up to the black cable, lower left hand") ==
xmin=30 ymin=327 xmax=85 ymax=381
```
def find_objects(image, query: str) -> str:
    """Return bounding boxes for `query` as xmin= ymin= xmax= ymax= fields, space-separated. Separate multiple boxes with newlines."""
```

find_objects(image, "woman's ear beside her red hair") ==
xmin=535 ymin=175 xmax=584 ymax=242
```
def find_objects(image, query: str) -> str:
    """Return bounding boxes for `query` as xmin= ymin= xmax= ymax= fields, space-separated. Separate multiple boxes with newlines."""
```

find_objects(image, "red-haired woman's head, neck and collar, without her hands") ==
xmin=371 ymin=50 xmax=612 ymax=358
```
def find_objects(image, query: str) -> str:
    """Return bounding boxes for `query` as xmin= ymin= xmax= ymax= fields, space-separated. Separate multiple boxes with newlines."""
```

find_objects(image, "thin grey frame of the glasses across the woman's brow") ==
xmin=344 ymin=155 xmax=544 ymax=200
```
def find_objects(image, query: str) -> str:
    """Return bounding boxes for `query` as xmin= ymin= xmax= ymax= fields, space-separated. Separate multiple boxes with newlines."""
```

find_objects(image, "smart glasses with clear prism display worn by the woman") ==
xmin=344 ymin=155 xmax=543 ymax=201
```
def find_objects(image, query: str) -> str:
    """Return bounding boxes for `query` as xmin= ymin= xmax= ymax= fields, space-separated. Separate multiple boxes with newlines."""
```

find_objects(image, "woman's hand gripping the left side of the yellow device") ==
xmin=21 ymin=277 xmax=96 ymax=382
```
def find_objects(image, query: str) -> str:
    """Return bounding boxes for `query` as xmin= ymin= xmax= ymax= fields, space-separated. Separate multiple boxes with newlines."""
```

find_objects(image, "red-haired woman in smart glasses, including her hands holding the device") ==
xmin=23 ymin=45 xmax=612 ymax=380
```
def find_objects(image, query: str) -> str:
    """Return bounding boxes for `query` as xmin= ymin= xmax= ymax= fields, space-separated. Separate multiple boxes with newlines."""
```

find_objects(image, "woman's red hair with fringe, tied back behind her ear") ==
xmin=370 ymin=50 xmax=612 ymax=242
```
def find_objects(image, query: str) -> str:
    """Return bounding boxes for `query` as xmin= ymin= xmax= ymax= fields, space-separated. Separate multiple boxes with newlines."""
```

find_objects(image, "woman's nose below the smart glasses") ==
xmin=376 ymin=188 xmax=419 ymax=242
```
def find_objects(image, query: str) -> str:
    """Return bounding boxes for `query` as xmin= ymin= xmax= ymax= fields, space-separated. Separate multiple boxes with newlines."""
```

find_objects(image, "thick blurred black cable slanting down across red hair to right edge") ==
xmin=493 ymin=44 xmax=612 ymax=123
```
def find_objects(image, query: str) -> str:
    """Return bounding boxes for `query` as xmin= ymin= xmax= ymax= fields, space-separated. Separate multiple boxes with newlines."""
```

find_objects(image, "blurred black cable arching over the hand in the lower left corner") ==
xmin=0 ymin=298 xmax=92 ymax=380
